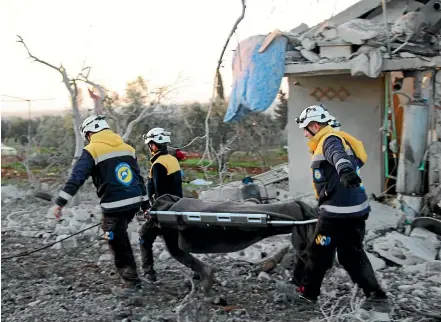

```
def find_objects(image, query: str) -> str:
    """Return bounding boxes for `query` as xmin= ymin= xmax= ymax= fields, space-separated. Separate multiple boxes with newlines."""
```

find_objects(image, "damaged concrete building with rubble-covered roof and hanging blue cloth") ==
xmin=217 ymin=0 xmax=441 ymax=220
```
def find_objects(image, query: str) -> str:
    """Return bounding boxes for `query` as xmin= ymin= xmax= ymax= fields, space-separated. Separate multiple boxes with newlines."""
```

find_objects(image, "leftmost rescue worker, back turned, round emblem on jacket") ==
xmin=54 ymin=115 xmax=148 ymax=291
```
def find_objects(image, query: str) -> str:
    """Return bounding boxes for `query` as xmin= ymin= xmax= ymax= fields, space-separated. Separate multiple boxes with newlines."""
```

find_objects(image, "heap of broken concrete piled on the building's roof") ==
xmin=282 ymin=11 xmax=441 ymax=78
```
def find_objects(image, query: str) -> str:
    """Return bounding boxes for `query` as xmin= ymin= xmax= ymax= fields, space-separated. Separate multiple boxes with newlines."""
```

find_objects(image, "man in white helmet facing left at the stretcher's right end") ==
xmin=296 ymin=105 xmax=387 ymax=302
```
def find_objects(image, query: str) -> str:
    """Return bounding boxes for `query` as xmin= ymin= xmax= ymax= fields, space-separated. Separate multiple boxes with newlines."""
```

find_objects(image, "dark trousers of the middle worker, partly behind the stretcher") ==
xmin=139 ymin=220 xmax=204 ymax=277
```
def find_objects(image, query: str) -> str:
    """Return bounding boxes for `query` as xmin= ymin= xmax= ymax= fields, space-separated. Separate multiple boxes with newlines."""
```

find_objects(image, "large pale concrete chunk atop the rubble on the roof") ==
xmin=337 ymin=19 xmax=384 ymax=45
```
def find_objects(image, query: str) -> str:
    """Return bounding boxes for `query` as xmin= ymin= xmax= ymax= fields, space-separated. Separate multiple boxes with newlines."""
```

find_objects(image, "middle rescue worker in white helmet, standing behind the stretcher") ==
xmin=139 ymin=128 xmax=213 ymax=290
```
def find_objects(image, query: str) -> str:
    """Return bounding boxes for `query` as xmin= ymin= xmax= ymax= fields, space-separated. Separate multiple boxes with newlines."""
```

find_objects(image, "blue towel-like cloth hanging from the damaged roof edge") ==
xmin=224 ymin=35 xmax=288 ymax=123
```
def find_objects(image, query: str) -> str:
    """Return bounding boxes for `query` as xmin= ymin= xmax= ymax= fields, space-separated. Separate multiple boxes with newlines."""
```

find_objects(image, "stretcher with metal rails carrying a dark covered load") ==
xmin=149 ymin=195 xmax=318 ymax=253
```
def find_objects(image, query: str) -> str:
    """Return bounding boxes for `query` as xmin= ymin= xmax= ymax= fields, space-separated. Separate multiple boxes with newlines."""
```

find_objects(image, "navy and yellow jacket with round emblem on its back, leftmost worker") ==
xmin=55 ymin=130 xmax=147 ymax=214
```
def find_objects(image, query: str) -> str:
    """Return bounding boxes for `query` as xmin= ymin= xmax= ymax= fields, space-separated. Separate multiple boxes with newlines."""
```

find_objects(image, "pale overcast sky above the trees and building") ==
xmin=0 ymin=0 xmax=358 ymax=112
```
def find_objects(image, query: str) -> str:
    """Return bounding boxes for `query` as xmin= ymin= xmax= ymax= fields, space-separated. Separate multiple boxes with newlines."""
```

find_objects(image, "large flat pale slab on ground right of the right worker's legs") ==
xmin=373 ymin=231 xmax=437 ymax=265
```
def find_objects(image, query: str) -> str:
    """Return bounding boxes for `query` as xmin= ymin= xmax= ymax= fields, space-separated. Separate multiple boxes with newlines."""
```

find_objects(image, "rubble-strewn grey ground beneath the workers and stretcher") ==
xmin=1 ymin=185 xmax=441 ymax=322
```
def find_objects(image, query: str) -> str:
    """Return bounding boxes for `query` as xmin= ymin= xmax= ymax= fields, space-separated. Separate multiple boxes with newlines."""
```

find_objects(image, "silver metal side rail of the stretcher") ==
xmin=149 ymin=210 xmax=317 ymax=228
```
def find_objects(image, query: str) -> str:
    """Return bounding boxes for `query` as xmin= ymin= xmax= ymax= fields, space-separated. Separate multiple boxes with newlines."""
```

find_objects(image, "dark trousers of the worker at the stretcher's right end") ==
xmin=299 ymin=218 xmax=381 ymax=298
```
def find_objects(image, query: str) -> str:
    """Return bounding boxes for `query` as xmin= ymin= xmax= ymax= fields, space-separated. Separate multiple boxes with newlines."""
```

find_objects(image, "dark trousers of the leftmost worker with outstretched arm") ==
xmin=102 ymin=210 xmax=138 ymax=283
